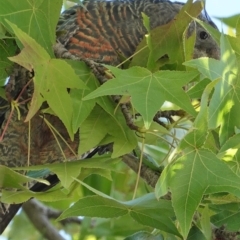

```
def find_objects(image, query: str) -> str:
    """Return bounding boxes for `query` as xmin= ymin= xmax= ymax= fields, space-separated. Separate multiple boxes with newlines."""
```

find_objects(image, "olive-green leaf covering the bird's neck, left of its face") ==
xmin=131 ymin=1 xmax=202 ymax=69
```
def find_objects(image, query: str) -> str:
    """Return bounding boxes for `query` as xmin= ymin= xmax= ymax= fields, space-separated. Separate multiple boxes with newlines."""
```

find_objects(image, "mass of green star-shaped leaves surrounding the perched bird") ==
xmin=0 ymin=0 xmax=240 ymax=240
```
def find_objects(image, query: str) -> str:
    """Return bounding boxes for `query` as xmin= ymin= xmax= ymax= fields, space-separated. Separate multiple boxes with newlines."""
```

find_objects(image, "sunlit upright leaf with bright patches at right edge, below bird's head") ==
xmin=185 ymin=35 xmax=240 ymax=144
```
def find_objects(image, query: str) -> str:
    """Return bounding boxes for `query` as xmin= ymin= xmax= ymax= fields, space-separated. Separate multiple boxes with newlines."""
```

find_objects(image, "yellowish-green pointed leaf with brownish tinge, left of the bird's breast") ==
xmin=8 ymin=22 xmax=85 ymax=137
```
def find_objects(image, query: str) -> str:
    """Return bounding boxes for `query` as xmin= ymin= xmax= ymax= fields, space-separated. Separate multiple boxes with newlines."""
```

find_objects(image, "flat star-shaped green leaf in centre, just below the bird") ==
xmin=84 ymin=66 xmax=198 ymax=129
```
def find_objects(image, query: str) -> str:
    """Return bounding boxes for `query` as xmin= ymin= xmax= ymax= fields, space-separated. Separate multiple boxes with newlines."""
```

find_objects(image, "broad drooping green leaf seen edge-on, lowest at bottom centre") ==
xmin=58 ymin=191 xmax=180 ymax=236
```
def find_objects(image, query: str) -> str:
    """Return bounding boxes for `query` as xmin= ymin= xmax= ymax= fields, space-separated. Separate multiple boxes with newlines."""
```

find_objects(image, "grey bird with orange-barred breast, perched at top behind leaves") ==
xmin=56 ymin=0 xmax=219 ymax=65
